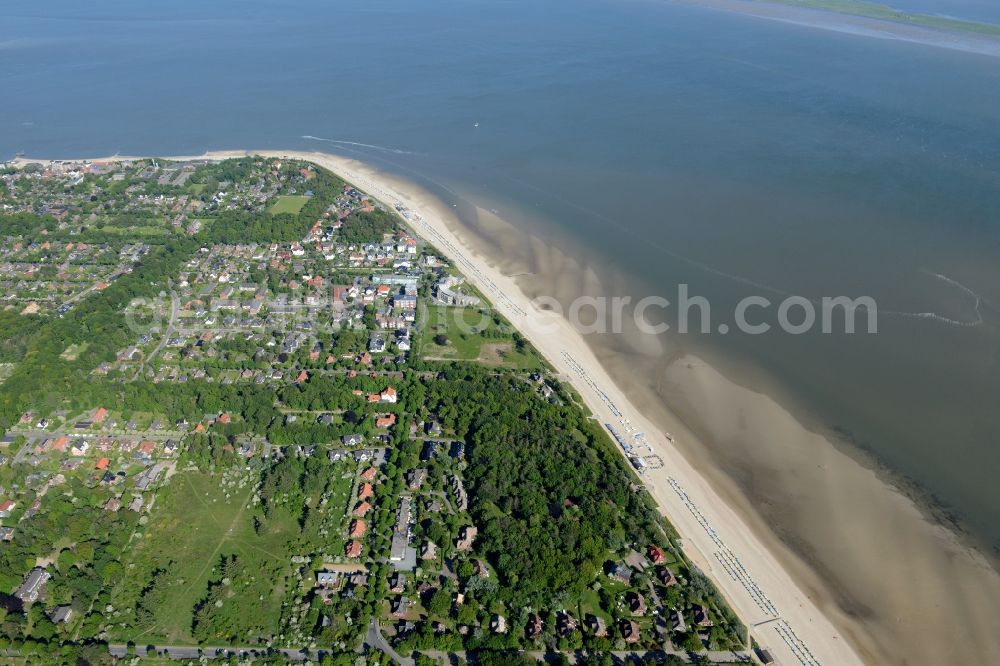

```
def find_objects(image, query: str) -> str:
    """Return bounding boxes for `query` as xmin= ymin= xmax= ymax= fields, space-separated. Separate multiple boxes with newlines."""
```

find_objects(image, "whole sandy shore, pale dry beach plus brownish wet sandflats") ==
xmin=25 ymin=151 xmax=1000 ymax=666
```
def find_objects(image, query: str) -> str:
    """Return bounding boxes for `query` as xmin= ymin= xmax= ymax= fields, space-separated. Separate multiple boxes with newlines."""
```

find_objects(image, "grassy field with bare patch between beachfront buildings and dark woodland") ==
xmin=420 ymin=305 xmax=542 ymax=370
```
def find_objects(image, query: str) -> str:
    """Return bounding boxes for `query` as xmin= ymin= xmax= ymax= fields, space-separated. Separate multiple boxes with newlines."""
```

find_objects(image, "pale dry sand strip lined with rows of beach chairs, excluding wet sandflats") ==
xmin=189 ymin=152 xmax=863 ymax=666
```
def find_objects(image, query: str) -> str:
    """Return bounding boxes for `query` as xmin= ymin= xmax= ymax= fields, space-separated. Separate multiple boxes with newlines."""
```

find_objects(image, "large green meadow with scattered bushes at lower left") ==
xmin=110 ymin=471 xmax=298 ymax=644
